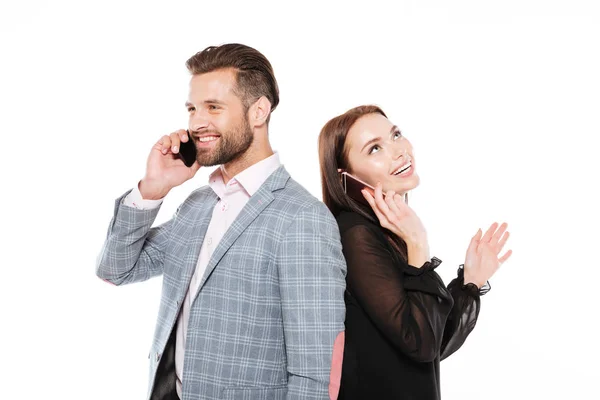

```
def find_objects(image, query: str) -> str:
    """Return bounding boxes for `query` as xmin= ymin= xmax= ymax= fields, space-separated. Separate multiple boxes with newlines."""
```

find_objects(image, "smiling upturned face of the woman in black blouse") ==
xmin=346 ymin=114 xmax=419 ymax=194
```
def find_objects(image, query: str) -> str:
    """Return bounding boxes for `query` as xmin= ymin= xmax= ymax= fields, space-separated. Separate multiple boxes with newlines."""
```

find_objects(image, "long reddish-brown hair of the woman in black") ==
xmin=319 ymin=105 xmax=408 ymax=261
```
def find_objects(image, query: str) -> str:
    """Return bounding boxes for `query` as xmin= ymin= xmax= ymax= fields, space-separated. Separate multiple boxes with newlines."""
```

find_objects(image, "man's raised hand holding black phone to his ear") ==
xmin=138 ymin=129 xmax=200 ymax=200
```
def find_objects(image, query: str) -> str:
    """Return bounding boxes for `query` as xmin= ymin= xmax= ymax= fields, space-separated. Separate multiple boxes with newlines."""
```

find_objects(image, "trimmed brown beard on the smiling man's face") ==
xmin=196 ymin=118 xmax=254 ymax=167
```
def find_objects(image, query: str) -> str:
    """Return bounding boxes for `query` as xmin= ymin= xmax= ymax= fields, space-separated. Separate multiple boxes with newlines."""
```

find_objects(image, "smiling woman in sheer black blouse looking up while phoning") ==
xmin=319 ymin=106 xmax=511 ymax=400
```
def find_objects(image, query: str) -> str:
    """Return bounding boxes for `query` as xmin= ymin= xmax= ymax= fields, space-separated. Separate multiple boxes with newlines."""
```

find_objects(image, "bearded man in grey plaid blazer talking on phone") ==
xmin=97 ymin=44 xmax=346 ymax=400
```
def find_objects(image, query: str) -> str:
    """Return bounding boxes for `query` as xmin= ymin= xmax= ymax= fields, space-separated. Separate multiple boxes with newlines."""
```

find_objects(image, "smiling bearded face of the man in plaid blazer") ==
xmin=186 ymin=69 xmax=254 ymax=166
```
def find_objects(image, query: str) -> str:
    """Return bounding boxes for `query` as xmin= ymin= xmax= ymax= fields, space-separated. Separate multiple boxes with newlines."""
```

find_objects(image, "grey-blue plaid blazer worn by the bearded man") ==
xmin=96 ymin=166 xmax=346 ymax=400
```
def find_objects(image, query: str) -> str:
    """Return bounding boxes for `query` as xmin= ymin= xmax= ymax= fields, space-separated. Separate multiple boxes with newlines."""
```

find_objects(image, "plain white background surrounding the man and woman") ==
xmin=0 ymin=0 xmax=600 ymax=400
